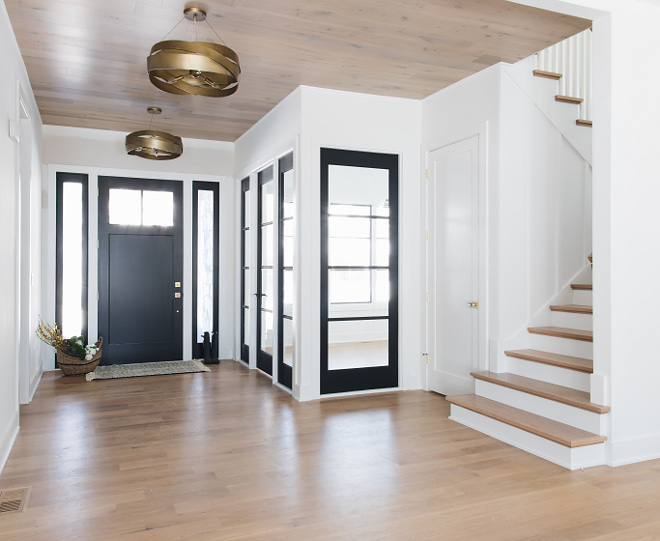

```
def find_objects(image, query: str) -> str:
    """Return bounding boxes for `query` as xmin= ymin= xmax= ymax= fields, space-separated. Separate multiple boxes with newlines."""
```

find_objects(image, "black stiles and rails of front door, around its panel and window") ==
xmin=98 ymin=176 xmax=183 ymax=364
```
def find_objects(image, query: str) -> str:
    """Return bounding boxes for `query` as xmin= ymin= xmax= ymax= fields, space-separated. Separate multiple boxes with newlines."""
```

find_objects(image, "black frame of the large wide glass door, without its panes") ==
xmin=320 ymin=148 xmax=399 ymax=394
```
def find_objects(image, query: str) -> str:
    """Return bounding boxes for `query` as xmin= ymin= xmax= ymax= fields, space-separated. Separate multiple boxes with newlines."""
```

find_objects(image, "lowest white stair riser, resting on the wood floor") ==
xmin=449 ymin=404 xmax=605 ymax=470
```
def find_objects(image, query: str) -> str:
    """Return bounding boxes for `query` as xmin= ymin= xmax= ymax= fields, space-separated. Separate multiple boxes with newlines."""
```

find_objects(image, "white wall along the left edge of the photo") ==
xmin=0 ymin=3 xmax=42 ymax=470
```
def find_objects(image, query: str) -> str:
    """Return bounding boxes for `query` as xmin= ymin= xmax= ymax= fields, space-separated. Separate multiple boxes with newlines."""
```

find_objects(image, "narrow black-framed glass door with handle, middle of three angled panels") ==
xmin=255 ymin=165 xmax=276 ymax=376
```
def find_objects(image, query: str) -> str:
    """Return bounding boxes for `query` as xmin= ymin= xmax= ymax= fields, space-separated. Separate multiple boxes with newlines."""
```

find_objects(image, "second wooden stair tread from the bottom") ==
xmin=471 ymin=371 xmax=610 ymax=414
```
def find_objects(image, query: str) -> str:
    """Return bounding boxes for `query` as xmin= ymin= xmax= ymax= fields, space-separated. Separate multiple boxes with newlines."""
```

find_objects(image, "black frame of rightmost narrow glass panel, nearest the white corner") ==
xmin=277 ymin=152 xmax=295 ymax=389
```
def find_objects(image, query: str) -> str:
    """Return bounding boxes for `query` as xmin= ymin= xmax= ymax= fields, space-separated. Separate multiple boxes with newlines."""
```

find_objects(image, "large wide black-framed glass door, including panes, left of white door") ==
xmin=320 ymin=148 xmax=399 ymax=394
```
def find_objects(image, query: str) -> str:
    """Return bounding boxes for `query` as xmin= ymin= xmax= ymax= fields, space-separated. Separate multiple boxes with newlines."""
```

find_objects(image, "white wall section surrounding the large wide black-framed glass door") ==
xmin=294 ymin=87 xmax=424 ymax=400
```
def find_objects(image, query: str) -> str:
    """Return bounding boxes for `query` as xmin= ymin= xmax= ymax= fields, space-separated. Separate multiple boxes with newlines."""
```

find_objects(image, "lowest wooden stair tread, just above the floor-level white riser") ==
xmin=447 ymin=394 xmax=607 ymax=448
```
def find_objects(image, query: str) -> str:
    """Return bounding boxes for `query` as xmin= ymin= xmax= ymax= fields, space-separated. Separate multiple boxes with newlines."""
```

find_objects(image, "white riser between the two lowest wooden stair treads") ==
xmin=476 ymin=380 xmax=607 ymax=435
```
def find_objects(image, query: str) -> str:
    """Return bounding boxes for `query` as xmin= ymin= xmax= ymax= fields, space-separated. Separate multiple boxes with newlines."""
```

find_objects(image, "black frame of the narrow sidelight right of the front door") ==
xmin=192 ymin=180 xmax=220 ymax=359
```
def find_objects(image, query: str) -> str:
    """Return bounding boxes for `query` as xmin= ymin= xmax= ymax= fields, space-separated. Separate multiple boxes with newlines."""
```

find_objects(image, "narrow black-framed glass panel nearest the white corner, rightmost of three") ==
xmin=277 ymin=153 xmax=295 ymax=389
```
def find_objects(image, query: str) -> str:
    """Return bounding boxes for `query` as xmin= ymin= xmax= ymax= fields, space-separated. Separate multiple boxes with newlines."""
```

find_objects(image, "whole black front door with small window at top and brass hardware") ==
xmin=99 ymin=177 xmax=183 ymax=364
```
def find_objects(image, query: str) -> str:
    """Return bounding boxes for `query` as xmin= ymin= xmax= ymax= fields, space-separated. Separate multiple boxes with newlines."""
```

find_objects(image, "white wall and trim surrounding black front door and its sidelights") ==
xmin=43 ymin=126 xmax=235 ymax=370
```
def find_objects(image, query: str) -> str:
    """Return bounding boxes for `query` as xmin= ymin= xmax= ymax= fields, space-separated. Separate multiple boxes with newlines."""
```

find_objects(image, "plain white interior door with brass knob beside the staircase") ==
xmin=426 ymin=135 xmax=479 ymax=395
